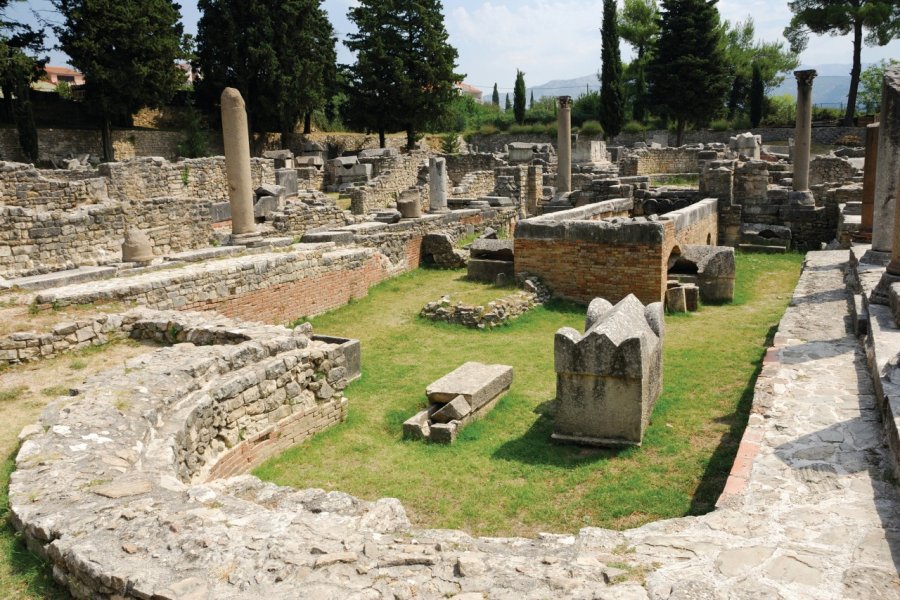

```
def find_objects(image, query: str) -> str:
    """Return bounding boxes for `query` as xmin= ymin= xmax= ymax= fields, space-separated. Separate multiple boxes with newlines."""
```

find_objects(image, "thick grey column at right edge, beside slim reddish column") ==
xmin=872 ymin=65 xmax=900 ymax=252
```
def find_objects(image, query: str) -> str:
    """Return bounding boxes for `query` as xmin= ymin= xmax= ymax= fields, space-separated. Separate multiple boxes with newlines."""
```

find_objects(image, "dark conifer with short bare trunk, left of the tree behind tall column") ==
xmin=53 ymin=0 xmax=185 ymax=160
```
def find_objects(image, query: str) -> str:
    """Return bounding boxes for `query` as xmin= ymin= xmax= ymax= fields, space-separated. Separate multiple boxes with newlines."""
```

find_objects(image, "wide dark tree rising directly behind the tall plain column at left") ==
xmin=195 ymin=0 xmax=337 ymax=146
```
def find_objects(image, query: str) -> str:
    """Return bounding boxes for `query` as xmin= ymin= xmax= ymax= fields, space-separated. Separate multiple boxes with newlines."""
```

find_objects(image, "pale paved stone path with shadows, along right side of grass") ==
xmin=625 ymin=251 xmax=900 ymax=600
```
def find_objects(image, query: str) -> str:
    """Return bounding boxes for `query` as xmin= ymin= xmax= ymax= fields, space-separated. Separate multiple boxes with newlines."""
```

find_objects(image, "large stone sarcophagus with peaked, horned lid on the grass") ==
xmin=552 ymin=294 xmax=665 ymax=446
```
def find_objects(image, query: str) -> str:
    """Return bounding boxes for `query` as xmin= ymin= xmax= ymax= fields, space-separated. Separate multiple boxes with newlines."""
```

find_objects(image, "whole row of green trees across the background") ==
xmin=0 ymin=0 xmax=900 ymax=160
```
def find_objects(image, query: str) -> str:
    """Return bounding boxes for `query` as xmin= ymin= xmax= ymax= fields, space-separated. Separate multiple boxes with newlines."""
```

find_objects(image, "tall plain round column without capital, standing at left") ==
xmin=221 ymin=88 xmax=258 ymax=243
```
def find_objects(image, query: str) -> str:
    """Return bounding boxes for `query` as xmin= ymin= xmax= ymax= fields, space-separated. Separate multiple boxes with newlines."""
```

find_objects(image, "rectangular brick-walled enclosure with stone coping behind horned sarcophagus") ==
xmin=515 ymin=199 xmax=718 ymax=304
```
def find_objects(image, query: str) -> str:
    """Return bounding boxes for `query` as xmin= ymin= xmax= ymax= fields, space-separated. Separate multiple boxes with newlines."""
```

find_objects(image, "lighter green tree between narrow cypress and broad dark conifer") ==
xmin=618 ymin=0 xmax=659 ymax=123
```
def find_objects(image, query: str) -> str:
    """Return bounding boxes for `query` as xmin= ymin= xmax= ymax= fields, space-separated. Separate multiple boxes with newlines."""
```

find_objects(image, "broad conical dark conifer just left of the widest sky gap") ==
xmin=346 ymin=0 xmax=464 ymax=148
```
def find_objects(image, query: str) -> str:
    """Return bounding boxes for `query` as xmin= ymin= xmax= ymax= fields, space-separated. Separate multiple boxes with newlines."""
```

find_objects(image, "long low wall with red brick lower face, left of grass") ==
xmin=36 ymin=209 xmax=515 ymax=323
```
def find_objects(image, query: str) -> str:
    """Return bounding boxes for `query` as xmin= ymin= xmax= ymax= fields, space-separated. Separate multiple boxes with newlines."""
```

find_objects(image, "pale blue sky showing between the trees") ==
xmin=9 ymin=0 xmax=900 ymax=92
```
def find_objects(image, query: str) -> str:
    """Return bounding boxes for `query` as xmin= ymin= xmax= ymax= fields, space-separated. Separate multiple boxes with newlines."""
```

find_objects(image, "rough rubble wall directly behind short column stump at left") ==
xmin=0 ymin=198 xmax=212 ymax=277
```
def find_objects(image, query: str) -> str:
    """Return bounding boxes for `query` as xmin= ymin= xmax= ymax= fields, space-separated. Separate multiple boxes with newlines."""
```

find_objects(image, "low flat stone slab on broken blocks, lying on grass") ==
xmin=403 ymin=362 xmax=513 ymax=444
